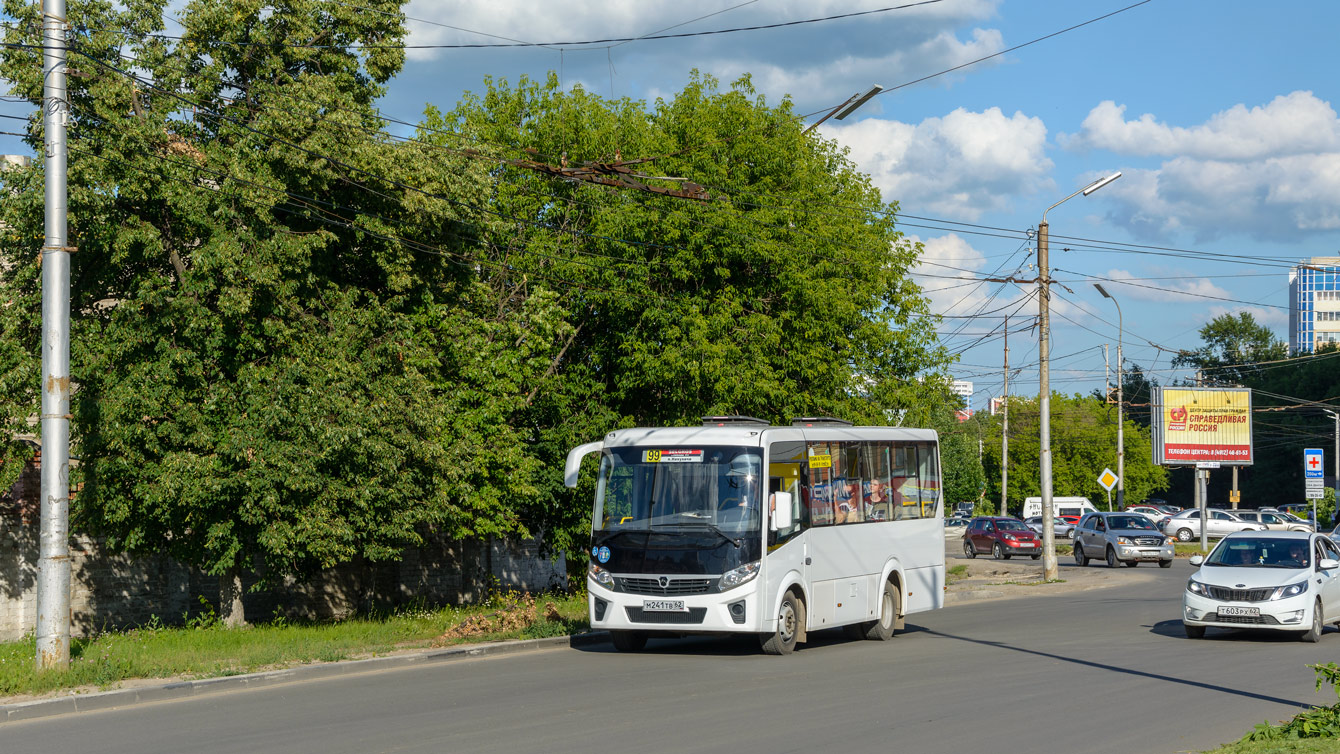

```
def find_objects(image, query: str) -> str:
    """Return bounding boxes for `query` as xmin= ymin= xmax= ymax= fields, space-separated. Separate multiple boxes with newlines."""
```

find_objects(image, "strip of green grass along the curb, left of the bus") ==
xmin=0 ymin=593 xmax=588 ymax=702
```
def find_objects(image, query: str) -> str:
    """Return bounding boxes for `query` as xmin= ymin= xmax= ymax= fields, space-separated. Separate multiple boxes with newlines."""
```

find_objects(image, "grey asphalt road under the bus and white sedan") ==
xmin=0 ymin=560 xmax=1340 ymax=754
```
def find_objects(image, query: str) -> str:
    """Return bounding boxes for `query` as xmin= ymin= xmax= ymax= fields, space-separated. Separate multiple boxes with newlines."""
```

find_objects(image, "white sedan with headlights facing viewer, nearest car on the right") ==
xmin=1182 ymin=532 xmax=1340 ymax=642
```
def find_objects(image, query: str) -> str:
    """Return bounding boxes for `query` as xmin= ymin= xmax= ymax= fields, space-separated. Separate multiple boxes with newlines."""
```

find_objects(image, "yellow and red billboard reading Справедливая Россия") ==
xmin=1152 ymin=387 xmax=1252 ymax=466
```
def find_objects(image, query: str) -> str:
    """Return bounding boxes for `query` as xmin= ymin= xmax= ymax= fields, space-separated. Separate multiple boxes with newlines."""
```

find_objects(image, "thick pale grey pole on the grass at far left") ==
xmin=36 ymin=0 xmax=72 ymax=671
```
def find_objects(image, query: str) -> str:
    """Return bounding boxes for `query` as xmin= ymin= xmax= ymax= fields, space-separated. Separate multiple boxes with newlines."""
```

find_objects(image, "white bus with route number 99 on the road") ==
xmin=564 ymin=417 xmax=945 ymax=654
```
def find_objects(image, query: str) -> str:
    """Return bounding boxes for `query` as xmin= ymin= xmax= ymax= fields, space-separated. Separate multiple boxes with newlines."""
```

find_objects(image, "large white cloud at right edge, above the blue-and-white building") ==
xmin=1060 ymin=91 xmax=1340 ymax=241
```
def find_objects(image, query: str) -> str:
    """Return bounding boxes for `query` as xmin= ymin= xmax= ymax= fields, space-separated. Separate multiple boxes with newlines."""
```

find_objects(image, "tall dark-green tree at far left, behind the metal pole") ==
xmin=0 ymin=0 xmax=538 ymax=623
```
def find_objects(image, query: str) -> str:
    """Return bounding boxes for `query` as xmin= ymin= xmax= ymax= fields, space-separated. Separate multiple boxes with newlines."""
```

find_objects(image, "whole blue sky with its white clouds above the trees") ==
xmin=9 ymin=0 xmax=1340 ymax=407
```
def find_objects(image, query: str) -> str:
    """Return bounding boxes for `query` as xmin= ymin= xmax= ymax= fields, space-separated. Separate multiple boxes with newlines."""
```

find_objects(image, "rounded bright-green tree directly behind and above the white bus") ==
xmin=434 ymin=75 xmax=947 ymax=544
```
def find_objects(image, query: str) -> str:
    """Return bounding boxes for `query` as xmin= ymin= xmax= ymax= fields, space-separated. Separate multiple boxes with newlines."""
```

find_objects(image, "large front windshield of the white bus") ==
xmin=591 ymin=446 xmax=762 ymax=533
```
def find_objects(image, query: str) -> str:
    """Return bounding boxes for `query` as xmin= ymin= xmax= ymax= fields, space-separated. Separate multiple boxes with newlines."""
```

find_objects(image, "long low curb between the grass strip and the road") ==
xmin=0 ymin=631 xmax=608 ymax=725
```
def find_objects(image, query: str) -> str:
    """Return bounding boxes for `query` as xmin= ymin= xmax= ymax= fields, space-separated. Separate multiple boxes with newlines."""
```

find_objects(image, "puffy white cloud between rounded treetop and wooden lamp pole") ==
xmin=821 ymin=107 xmax=1052 ymax=220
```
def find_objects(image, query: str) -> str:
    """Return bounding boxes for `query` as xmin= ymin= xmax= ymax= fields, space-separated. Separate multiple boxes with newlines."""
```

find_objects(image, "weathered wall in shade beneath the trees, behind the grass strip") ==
xmin=0 ymin=458 xmax=567 ymax=640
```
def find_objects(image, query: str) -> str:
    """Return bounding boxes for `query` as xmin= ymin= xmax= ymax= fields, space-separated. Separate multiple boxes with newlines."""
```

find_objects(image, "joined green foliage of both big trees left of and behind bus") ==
xmin=0 ymin=7 xmax=946 ymax=626
